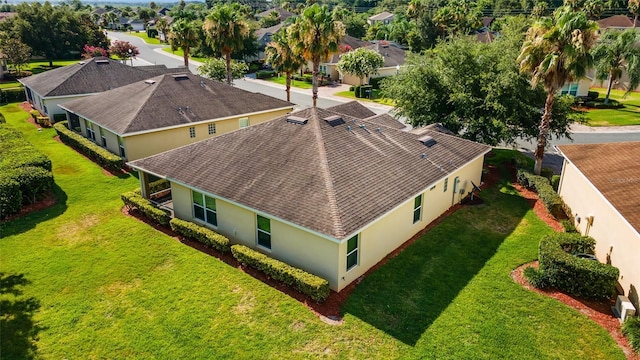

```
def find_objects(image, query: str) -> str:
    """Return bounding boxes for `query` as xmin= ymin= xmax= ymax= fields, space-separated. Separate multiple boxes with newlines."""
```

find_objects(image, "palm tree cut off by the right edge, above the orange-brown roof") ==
xmin=593 ymin=29 xmax=640 ymax=104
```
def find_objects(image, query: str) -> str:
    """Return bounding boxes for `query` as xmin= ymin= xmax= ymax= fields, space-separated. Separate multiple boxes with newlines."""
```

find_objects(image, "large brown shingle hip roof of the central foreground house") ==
xmin=129 ymin=108 xmax=490 ymax=239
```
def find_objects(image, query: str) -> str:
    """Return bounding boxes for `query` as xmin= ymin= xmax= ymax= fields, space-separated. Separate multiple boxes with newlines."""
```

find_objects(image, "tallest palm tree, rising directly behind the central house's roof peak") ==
xmin=288 ymin=4 xmax=345 ymax=107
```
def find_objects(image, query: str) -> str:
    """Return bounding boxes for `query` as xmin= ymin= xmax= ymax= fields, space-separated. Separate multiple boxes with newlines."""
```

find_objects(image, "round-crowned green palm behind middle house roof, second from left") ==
xmin=202 ymin=3 xmax=249 ymax=85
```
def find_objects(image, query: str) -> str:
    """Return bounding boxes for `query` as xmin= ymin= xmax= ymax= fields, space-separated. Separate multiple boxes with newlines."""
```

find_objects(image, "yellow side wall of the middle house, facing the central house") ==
xmin=125 ymin=108 xmax=291 ymax=161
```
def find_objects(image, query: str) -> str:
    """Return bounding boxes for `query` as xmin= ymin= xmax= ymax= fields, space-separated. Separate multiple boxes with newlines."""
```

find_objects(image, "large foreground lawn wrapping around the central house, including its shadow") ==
xmin=0 ymin=105 xmax=624 ymax=359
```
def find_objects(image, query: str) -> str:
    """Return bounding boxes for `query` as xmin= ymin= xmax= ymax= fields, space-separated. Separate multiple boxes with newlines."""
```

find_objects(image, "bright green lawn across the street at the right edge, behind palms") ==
xmin=586 ymin=88 xmax=640 ymax=126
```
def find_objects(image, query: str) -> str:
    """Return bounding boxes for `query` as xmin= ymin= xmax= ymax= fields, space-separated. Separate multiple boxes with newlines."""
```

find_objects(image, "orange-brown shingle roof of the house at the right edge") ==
xmin=558 ymin=141 xmax=640 ymax=232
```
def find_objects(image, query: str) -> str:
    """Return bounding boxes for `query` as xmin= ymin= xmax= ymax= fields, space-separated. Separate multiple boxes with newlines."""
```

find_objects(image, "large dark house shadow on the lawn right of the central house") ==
xmin=342 ymin=186 xmax=530 ymax=346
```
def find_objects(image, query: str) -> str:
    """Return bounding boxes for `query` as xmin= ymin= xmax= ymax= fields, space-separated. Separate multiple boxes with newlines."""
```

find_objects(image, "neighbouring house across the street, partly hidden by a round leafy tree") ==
xmin=320 ymin=35 xmax=407 ymax=85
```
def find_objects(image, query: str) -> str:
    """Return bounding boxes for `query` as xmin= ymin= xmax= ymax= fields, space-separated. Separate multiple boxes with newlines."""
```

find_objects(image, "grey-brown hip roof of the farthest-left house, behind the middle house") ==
xmin=20 ymin=58 xmax=179 ymax=97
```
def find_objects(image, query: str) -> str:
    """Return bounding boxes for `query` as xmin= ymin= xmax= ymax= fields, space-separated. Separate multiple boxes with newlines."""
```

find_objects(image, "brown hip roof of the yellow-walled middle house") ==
xmin=62 ymin=73 xmax=293 ymax=134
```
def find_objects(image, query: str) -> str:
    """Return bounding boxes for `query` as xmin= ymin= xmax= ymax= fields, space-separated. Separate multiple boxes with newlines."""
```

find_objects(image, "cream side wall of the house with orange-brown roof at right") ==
xmin=558 ymin=160 xmax=640 ymax=308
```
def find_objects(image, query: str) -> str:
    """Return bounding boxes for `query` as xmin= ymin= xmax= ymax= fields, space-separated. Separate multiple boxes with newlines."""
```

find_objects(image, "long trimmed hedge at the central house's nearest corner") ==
xmin=231 ymin=245 xmax=330 ymax=302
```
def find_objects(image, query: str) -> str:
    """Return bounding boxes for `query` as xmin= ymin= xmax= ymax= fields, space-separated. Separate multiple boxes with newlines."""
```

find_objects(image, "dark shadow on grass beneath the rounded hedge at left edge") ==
xmin=0 ymin=183 xmax=67 ymax=238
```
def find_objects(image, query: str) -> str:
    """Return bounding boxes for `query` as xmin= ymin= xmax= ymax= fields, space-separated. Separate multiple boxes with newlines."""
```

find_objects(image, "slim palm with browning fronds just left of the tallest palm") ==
xmin=264 ymin=29 xmax=305 ymax=101
